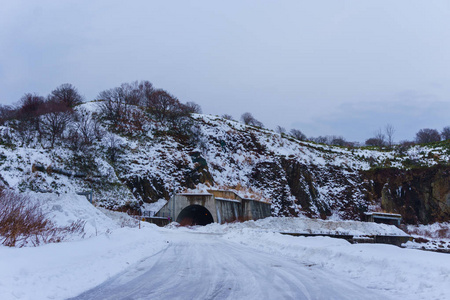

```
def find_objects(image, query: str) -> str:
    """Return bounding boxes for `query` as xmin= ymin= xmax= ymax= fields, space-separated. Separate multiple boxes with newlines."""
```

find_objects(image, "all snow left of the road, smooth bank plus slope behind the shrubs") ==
xmin=0 ymin=193 xmax=167 ymax=299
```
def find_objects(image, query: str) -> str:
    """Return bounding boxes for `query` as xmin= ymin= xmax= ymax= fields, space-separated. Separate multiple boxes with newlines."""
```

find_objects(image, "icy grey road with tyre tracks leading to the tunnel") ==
xmin=72 ymin=232 xmax=386 ymax=300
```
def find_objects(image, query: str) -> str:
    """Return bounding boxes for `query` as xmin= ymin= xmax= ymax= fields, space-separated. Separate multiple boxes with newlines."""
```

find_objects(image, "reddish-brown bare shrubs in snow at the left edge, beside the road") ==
xmin=0 ymin=190 xmax=85 ymax=247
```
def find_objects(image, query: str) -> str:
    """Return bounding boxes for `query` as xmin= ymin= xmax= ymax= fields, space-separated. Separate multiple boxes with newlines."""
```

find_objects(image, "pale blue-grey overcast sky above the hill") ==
xmin=0 ymin=0 xmax=450 ymax=142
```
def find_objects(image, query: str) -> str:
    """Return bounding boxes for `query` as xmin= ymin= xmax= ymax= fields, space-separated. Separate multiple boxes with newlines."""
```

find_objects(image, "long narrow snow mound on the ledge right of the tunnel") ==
xmin=190 ymin=217 xmax=407 ymax=236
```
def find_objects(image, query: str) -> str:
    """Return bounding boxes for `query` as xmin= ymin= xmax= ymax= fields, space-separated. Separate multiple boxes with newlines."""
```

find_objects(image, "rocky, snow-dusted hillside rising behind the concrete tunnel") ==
xmin=0 ymin=102 xmax=450 ymax=223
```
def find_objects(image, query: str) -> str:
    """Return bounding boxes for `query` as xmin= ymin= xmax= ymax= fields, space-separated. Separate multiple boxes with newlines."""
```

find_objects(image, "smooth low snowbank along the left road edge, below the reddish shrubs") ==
xmin=0 ymin=224 xmax=168 ymax=299
